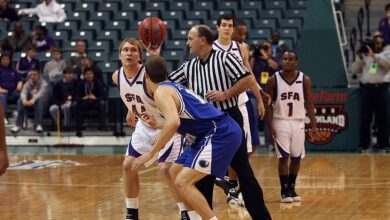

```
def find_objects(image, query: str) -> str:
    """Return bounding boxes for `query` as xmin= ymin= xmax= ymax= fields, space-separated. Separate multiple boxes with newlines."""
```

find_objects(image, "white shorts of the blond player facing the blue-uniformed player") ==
xmin=126 ymin=120 xmax=184 ymax=163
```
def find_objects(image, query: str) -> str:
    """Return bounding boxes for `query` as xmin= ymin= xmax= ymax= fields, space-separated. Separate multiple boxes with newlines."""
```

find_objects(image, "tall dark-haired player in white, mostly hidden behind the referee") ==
xmin=213 ymin=14 xmax=264 ymax=205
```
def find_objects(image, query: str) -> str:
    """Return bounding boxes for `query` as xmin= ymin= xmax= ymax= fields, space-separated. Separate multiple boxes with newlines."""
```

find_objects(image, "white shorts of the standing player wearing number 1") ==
xmin=272 ymin=118 xmax=305 ymax=159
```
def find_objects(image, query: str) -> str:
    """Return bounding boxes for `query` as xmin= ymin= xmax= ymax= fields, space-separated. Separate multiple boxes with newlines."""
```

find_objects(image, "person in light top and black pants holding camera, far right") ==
xmin=351 ymin=35 xmax=390 ymax=153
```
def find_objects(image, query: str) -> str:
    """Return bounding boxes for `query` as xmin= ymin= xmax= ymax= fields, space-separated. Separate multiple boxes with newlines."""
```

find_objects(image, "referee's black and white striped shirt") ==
xmin=168 ymin=50 xmax=250 ymax=110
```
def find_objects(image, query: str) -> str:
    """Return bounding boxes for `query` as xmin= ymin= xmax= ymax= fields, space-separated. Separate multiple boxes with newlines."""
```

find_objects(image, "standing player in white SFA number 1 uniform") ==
xmin=267 ymin=51 xmax=318 ymax=203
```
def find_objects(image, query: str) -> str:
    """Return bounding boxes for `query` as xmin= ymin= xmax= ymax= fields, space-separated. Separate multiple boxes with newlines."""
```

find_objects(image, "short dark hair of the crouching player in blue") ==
xmin=145 ymin=55 xmax=168 ymax=83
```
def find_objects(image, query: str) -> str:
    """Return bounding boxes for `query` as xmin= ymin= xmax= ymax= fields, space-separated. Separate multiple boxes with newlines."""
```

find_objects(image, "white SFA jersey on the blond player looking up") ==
xmin=118 ymin=65 xmax=164 ymax=127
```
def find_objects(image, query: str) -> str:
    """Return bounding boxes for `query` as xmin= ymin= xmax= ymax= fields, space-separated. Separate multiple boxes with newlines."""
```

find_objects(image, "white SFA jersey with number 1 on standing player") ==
xmin=273 ymin=72 xmax=306 ymax=119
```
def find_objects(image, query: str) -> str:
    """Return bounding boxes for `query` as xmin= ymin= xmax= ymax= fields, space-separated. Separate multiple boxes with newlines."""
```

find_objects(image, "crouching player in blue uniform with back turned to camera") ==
xmin=132 ymin=56 xmax=242 ymax=220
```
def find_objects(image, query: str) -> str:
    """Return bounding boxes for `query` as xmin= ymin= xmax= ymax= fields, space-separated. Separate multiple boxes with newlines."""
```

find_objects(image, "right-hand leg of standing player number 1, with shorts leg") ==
xmin=288 ymin=120 xmax=305 ymax=202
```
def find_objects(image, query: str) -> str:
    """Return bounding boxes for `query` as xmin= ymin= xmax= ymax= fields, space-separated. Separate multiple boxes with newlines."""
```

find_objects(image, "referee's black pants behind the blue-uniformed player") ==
xmin=196 ymin=106 xmax=271 ymax=220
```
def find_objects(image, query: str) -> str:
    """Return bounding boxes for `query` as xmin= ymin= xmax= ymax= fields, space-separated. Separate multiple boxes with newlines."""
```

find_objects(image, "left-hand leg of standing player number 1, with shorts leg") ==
xmin=273 ymin=119 xmax=293 ymax=202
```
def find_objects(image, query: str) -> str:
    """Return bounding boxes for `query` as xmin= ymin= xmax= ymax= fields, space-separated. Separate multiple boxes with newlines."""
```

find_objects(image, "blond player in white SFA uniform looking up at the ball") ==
xmin=112 ymin=38 xmax=189 ymax=219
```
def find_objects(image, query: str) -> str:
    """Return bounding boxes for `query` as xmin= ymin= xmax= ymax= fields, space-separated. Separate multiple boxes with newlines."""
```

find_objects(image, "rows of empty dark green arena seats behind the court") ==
xmin=0 ymin=0 xmax=308 ymax=134
